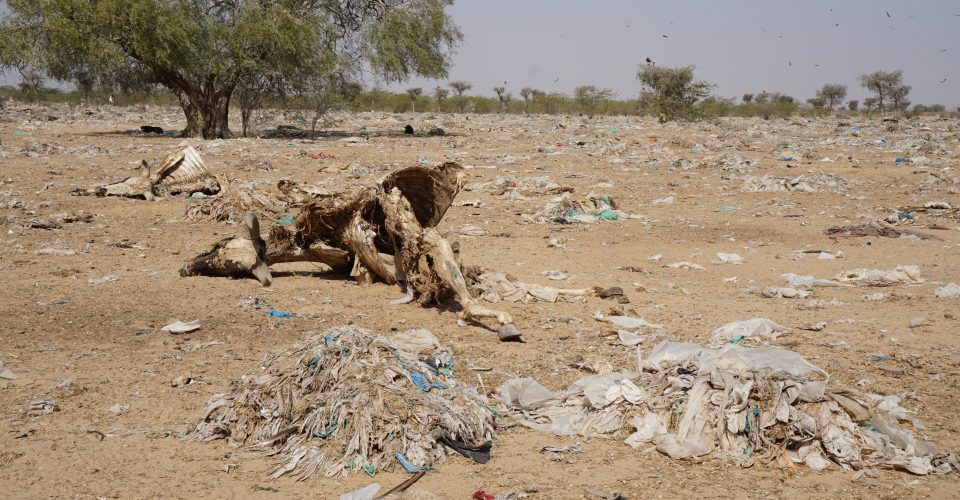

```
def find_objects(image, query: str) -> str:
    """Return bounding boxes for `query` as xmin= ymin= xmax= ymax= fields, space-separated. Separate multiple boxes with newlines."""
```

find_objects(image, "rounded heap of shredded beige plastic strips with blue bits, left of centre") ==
xmin=193 ymin=326 xmax=494 ymax=479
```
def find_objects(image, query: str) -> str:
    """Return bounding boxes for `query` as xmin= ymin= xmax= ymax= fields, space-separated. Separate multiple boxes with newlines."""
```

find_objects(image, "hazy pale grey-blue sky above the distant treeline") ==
xmin=387 ymin=0 xmax=960 ymax=109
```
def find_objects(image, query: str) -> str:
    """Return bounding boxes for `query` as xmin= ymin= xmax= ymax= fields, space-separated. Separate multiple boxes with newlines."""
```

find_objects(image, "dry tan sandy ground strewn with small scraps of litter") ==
xmin=0 ymin=105 xmax=960 ymax=498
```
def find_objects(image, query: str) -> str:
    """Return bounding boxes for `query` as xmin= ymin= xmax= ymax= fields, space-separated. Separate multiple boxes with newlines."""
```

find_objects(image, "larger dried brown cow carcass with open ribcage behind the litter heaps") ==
xmin=180 ymin=163 xmax=519 ymax=339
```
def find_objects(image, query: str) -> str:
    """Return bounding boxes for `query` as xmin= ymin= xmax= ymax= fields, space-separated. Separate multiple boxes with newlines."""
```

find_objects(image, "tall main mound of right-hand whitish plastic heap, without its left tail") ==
xmin=626 ymin=341 xmax=952 ymax=475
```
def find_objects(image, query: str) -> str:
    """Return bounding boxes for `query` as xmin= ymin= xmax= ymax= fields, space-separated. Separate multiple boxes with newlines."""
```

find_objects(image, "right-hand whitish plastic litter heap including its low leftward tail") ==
xmin=499 ymin=334 xmax=956 ymax=475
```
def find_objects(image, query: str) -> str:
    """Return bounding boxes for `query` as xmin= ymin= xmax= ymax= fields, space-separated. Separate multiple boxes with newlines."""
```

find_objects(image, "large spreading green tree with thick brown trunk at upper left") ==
xmin=0 ymin=0 xmax=461 ymax=138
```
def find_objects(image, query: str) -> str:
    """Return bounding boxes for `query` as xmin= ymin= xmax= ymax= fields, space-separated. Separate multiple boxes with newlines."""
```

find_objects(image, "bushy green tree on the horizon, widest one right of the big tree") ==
xmin=637 ymin=65 xmax=715 ymax=120
